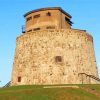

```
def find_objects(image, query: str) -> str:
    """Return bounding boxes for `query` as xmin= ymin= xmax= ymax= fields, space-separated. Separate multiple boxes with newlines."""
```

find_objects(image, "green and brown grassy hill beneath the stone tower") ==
xmin=0 ymin=85 xmax=100 ymax=100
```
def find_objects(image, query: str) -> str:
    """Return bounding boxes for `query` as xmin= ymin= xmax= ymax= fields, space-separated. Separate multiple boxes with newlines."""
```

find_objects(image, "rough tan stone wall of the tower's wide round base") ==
xmin=12 ymin=29 xmax=98 ymax=85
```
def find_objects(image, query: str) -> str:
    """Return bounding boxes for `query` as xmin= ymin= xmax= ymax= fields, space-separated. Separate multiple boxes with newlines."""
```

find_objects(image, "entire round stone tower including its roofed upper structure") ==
xmin=11 ymin=7 xmax=99 ymax=85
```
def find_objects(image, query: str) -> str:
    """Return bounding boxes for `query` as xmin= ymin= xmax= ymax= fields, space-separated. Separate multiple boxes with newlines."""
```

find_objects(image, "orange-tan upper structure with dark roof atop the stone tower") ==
xmin=24 ymin=7 xmax=72 ymax=32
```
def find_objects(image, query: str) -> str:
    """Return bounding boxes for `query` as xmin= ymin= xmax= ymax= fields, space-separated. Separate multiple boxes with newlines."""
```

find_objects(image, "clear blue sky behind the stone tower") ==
xmin=0 ymin=0 xmax=100 ymax=86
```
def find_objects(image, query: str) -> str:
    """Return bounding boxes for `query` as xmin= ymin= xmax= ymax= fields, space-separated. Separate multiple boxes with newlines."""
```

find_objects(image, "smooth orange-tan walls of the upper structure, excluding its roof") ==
xmin=26 ymin=10 xmax=70 ymax=32
